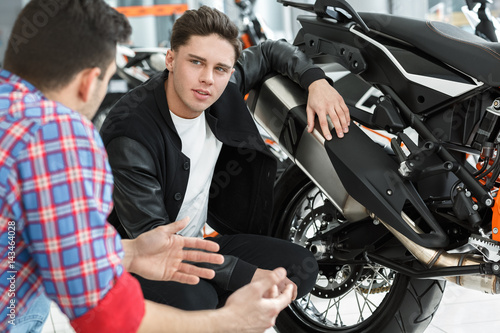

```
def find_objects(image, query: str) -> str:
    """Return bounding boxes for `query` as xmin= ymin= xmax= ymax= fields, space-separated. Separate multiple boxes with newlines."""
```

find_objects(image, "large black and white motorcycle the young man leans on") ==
xmin=247 ymin=0 xmax=500 ymax=333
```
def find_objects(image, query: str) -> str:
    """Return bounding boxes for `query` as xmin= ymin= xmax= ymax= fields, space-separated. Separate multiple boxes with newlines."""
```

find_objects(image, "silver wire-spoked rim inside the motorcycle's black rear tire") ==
xmin=283 ymin=183 xmax=397 ymax=331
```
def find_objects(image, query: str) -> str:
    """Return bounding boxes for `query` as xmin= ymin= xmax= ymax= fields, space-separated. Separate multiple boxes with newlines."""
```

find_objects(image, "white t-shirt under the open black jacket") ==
xmin=170 ymin=111 xmax=222 ymax=237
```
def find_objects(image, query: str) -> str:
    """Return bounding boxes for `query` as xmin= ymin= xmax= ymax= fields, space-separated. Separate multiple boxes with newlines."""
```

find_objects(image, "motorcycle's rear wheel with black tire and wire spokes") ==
xmin=273 ymin=166 xmax=444 ymax=333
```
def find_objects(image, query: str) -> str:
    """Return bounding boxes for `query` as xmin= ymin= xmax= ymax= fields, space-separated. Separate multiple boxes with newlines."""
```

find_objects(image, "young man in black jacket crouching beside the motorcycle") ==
xmin=101 ymin=7 xmax=349 ymax=310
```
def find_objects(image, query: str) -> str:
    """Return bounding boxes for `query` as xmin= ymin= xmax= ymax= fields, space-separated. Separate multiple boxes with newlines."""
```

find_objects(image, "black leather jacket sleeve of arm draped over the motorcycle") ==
xmin=231 ymin=40 xmax=331 ymax=95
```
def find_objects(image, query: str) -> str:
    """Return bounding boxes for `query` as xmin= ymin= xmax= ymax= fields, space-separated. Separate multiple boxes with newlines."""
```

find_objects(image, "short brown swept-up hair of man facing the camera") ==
xmin=170 ymin=6 xmax=241 ymax=61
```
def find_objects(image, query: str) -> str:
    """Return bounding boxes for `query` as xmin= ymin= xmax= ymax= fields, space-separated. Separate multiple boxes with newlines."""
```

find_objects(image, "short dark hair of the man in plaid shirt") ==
xmin=4 ymin=0 xmax=132 ymax=90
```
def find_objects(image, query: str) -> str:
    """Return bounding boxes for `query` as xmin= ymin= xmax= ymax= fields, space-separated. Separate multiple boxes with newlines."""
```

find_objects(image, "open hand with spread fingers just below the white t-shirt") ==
xmin=122 ymin=218 xmax=224 ymax=284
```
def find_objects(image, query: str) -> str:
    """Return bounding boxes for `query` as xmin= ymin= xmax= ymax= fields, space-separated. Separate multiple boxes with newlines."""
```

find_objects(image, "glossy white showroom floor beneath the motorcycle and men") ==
xmin=42 ymin=284 xmax=500 ymax=333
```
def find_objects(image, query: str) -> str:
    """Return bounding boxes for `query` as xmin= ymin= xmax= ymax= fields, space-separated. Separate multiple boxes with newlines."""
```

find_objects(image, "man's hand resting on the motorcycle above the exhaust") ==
xmin=306 ymin=79 xmax=351 ymax=140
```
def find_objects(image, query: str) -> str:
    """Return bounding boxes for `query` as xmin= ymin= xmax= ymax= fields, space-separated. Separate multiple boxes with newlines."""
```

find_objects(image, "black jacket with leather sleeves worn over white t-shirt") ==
xmin=101 ymin=41 xmax=326 ymax=290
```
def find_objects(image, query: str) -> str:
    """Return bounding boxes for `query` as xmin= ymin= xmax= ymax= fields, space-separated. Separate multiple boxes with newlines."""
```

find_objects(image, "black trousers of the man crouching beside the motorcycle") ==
xmin=136 ymin=235 xmax=318 ymax=310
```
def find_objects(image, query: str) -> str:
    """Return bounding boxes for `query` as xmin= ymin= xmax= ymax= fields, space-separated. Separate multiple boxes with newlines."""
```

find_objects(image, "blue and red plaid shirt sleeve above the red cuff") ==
xmin=18 ymin=110 xmax=143 ymax=320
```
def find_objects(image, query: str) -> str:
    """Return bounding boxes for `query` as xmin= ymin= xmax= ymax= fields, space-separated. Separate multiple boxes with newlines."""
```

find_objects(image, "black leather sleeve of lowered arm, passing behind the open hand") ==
xmin=106 ymin=137 xmax=256 ymax=290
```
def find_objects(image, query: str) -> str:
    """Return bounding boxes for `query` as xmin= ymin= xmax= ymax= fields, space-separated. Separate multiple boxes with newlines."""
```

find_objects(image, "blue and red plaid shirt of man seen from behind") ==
xmin=0 ymin=70 xmax=123 ymax=331
